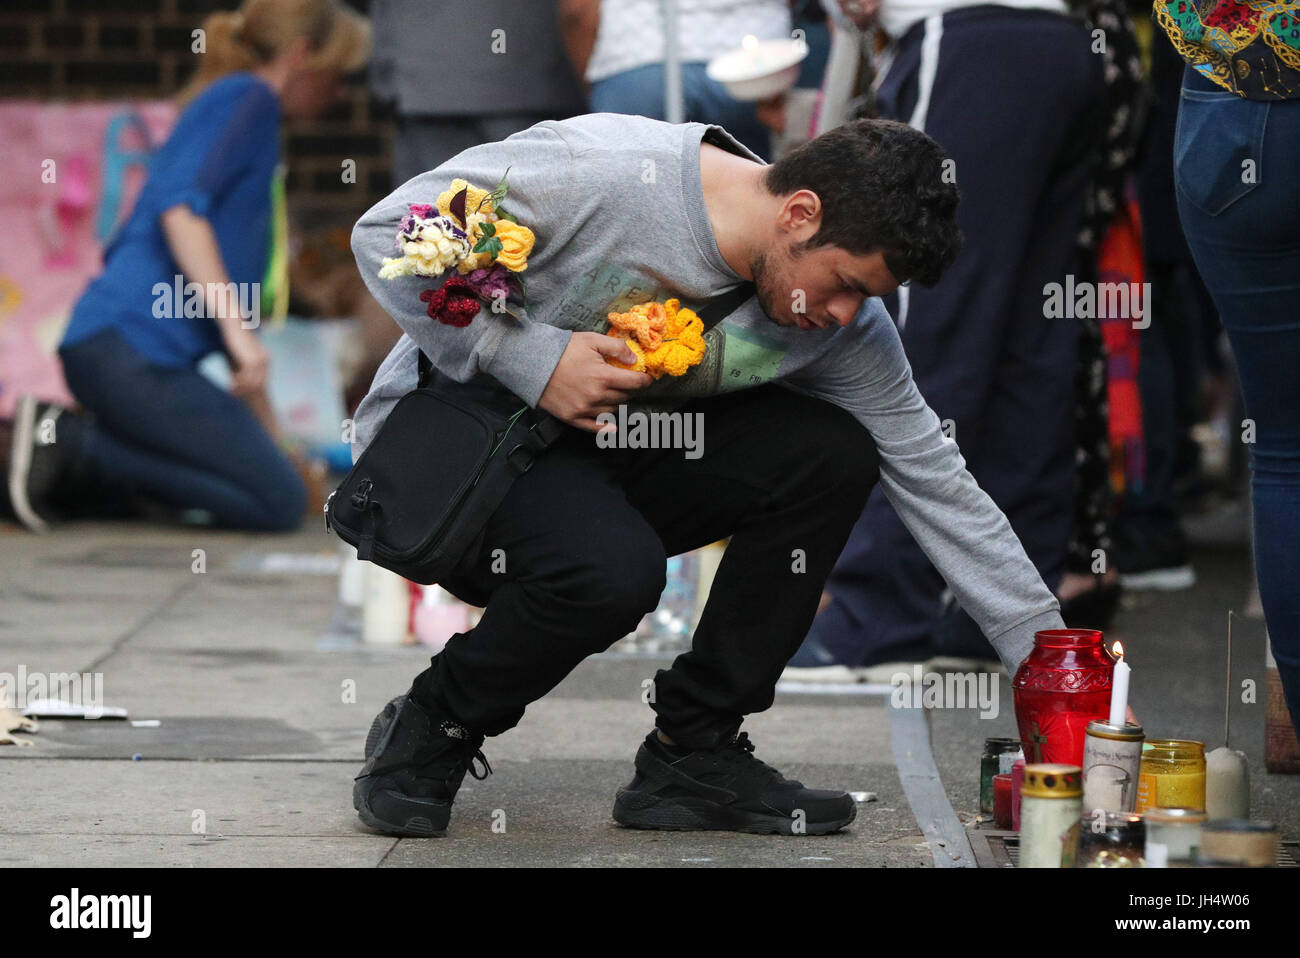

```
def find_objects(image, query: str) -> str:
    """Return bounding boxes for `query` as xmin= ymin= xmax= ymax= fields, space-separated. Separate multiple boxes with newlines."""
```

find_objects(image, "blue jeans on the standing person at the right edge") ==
xmin=1174 ymin=68 xmax=1300 ymax=724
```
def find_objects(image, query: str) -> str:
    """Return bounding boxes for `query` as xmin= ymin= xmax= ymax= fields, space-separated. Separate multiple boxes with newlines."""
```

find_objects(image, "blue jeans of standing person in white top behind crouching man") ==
xmin=592 ymin=64 xmax=772 ymax=160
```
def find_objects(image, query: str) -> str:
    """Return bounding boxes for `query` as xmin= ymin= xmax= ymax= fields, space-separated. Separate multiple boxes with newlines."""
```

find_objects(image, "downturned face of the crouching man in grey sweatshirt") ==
xmin=751 ymin=235 xmax=898 ymax=329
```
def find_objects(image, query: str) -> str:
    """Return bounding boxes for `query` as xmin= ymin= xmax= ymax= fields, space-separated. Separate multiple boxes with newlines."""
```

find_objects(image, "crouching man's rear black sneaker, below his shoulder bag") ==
xmin=352 ymin=695 xmax=491 ymax=837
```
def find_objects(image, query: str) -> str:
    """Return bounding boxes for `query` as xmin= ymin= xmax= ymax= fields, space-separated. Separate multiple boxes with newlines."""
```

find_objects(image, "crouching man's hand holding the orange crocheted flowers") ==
xmin=537 ymin=333 xmax=654 ymax=433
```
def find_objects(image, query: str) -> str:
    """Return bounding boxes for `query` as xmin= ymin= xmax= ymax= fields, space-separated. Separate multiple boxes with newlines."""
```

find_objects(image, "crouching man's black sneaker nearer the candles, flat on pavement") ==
xmin=614 ymin=732 xmax=858 ymax=835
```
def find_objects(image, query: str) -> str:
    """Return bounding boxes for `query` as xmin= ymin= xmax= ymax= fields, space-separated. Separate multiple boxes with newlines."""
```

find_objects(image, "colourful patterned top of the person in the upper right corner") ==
xmin=1153 ymin=0 xmax=1300 ymax=100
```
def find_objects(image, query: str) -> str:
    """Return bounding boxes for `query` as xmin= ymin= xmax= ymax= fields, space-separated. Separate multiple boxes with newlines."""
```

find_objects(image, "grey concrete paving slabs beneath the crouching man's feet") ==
xmin=0 ymin=514 xmax=1300 ymax=867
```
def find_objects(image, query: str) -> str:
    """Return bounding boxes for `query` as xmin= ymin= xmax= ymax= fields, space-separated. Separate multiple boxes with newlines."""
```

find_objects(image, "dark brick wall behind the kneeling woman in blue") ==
xmin=0 ymin=0 xmax=391 ymax=213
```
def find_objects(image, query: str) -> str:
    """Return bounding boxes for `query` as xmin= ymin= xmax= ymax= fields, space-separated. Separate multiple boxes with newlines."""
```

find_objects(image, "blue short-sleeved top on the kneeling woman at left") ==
xmin=62 ymin=73 xmax=280 ymax=367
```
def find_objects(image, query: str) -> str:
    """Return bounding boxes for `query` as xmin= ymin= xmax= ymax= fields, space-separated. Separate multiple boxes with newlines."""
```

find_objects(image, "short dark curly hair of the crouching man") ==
xmin=763 ymin=120 xmax=962 ymax=286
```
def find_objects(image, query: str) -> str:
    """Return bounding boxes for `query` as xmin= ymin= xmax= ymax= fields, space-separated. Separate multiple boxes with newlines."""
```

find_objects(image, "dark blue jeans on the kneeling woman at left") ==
xmin=57 ymin=329 xmax=307 ymax=532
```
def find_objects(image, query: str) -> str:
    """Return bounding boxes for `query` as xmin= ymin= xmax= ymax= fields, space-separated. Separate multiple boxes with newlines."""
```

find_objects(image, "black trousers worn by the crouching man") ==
xmin=413 ymin=383 xmax=879 ymax=747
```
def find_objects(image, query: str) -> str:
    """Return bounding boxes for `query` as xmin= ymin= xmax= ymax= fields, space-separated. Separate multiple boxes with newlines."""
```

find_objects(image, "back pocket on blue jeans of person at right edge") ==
xmin=1174 ymin=87 xmax=1269 ymax=216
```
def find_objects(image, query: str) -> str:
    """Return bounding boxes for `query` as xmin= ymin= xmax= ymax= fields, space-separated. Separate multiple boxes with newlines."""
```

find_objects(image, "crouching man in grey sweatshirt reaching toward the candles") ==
xmin=352 ymin=114 xmax=1062 ymax=836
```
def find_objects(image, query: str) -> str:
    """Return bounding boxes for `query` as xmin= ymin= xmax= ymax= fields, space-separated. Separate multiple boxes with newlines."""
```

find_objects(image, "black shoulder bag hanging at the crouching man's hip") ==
xmin=325 ymin=283 xmax=754 ymax=585
